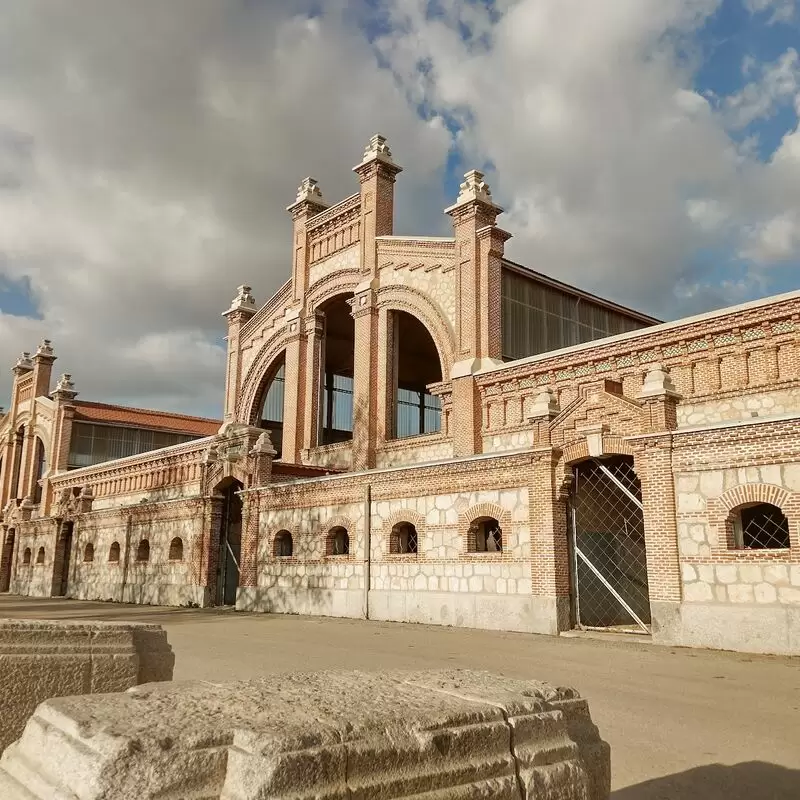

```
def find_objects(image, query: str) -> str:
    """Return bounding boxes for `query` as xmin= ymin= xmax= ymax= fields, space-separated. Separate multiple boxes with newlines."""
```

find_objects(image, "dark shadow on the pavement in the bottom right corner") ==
xmin=611 ymin=764 xmax=800 ymax=800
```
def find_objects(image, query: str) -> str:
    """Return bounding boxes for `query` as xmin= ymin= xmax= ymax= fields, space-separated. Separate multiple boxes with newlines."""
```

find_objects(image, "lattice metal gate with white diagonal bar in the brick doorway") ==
xmin=570 ymin=457 xmax=650 ymax=633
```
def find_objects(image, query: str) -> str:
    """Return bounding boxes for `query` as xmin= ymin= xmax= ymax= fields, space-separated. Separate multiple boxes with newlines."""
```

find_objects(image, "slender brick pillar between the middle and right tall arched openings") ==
xmin=351 ymin=281 xmax=378 ymax=470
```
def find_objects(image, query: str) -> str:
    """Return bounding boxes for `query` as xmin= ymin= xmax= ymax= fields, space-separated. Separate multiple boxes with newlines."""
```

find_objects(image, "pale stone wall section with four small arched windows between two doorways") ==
xmin=237 ymin=456 xmax=556 ymax=631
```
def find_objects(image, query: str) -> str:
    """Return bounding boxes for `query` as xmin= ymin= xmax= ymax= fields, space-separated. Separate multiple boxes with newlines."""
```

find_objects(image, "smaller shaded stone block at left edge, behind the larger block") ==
xmin=0 ymin=619 xmax=175 ymax=756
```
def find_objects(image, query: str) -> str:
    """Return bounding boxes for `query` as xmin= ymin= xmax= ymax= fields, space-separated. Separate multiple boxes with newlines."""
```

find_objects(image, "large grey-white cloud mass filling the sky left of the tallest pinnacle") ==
xmin=0 ymin=0 xmax=450 ymax=411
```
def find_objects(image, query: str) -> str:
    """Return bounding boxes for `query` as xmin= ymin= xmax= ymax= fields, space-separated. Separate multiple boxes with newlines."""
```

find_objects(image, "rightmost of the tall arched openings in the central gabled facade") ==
xmin=389 ymin=311 xmax=442 ymax=439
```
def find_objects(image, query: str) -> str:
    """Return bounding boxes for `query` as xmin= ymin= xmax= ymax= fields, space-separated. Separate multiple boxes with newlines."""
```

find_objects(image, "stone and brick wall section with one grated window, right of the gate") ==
xmin=674 ymin=421 xmax=800 ymax=653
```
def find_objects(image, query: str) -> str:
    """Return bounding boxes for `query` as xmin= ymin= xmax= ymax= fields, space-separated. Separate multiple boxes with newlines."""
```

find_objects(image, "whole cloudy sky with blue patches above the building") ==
xmin=0 ymin=0 xmax=800 ymax=416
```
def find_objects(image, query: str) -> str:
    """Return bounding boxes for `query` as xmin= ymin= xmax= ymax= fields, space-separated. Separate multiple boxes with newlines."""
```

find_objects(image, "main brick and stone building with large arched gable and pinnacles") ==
xmin=2 ymin=136 xmax=800 ymax=653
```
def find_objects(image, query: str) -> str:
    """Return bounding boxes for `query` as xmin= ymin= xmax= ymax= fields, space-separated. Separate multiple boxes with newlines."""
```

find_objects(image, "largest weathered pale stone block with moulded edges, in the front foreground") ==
xmin=0 ymin=670 xmax=610 ymax=800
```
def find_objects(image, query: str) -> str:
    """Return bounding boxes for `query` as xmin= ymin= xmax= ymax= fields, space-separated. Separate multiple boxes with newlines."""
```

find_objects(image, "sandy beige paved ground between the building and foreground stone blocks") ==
xmin=0 ymin=595 xmax=800 ymax=800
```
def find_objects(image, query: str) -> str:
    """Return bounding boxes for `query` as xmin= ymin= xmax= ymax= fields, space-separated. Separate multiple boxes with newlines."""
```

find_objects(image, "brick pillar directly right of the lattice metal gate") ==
xmin=634 ymin=434 xmax=681 ymax=643
